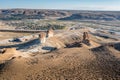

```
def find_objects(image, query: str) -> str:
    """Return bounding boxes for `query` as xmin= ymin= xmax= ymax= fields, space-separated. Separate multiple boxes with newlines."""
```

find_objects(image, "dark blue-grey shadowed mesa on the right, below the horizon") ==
xmin=59 ymin=11 xmax=120 ymax=21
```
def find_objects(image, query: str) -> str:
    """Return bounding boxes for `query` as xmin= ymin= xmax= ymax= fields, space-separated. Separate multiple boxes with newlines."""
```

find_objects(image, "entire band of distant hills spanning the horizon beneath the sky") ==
xmin=0 ymin=9 xmax=120 ymax=21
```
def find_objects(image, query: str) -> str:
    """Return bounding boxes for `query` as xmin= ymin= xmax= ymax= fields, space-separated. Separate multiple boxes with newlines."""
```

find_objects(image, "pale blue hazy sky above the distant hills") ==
xmin=0 ymin=0 xmax=120 ymax=10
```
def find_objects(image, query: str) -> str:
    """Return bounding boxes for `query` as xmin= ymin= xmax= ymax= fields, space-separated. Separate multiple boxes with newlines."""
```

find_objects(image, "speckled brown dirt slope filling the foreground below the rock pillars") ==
xmin=0 ymin=46 xmax=120 ymax=80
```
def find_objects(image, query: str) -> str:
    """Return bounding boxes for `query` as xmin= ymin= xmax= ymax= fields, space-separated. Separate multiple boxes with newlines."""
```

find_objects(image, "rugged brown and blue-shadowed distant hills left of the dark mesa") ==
xmin=0 ymin=9 xmax=69 ymax=20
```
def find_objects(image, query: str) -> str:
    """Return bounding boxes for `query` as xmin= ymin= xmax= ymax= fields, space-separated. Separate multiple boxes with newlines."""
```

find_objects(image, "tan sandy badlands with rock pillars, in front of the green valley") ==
xmin=0 ymin=20 xmax=120 ymax=80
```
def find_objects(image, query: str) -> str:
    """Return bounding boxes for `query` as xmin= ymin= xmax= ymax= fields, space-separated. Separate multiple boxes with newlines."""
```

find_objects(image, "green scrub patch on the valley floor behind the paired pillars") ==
xmin=4 ymin=20 xmax=67 ymax=30
